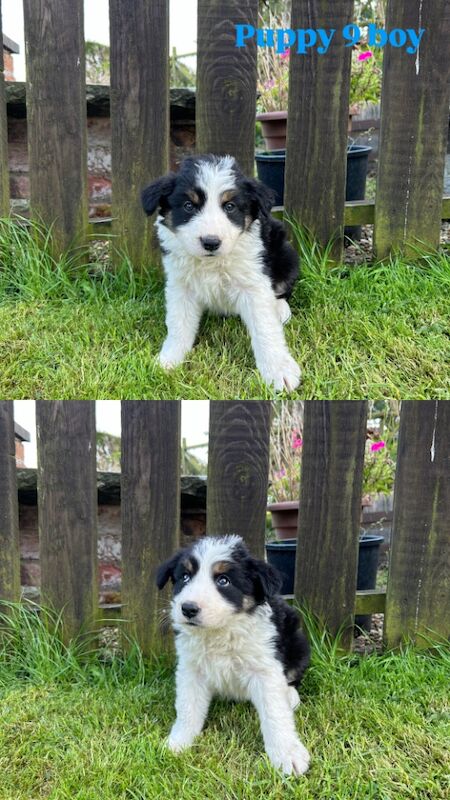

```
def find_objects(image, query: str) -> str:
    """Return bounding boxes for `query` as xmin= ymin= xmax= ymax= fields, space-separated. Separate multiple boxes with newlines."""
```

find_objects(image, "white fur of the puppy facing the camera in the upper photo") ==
xmin=155 ymin=157 xmax=300 ymax=391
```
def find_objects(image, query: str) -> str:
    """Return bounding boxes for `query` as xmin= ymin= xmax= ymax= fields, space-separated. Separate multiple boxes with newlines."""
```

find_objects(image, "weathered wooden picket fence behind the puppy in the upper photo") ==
xmin=0 ymin=0 xmax=450 ymax=267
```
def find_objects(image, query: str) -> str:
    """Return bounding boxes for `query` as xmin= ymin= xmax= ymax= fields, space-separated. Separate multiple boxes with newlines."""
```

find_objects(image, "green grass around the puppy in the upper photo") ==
xmin=0 ymin=220 xmax=450 ymax=399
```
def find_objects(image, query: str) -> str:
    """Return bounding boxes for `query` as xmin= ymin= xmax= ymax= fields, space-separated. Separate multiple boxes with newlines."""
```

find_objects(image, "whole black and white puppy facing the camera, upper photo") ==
xmin=142 ymin=155 xmax=300 ymax=391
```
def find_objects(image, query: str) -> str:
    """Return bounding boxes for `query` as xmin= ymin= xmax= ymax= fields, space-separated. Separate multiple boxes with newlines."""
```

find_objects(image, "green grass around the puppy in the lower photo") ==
xmin=0 ymin=607 xmax=450 ymax=800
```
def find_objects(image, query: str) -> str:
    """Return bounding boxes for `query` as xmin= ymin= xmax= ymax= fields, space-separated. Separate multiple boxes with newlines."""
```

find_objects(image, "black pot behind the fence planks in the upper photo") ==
xmin=255 ymin=145 xmax=372 ymax=241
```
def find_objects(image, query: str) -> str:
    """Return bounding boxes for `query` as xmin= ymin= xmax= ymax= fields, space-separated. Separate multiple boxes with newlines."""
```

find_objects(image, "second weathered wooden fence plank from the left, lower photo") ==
xmin=36 ymin=400 xmax=98 ymax=641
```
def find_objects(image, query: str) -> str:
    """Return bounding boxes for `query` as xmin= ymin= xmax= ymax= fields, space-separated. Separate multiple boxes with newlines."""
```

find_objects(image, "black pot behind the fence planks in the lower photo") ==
xmin=266 ymin=536 xmax=384 ymax=631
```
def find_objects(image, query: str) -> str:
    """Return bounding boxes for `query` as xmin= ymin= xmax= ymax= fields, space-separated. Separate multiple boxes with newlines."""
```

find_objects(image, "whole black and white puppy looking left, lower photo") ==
xmin=157 ymin=536 xmax=309 ymax=775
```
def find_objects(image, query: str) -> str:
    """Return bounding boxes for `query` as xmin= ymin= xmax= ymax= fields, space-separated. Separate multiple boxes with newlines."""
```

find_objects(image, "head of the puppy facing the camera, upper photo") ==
xmin=142 ymin=155 xmax=273 ymax=258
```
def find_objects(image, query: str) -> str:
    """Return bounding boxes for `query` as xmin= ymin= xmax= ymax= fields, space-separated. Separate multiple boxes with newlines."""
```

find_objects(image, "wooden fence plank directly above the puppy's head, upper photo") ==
xmin=196 ymin=0 xmax=258 ymax=175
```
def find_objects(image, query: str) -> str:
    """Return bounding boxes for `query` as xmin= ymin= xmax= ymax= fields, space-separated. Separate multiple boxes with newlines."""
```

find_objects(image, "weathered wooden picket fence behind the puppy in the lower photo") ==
xmin=0 ymin=400 xmax=450 ymax=654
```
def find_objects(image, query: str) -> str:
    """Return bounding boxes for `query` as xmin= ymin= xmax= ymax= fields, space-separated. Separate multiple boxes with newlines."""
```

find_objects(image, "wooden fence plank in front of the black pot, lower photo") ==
xmin=295 ymin=400 xmax=367 ymax=645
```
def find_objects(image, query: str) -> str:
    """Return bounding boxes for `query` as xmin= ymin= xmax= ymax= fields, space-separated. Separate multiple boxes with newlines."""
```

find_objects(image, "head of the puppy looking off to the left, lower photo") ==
xmin=157 ymin=536 xmax=282 ymax=628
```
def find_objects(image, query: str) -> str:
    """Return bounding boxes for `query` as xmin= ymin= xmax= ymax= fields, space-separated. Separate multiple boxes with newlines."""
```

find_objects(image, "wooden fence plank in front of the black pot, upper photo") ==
xmin=285 ymin=0 xmax=354 ymax=259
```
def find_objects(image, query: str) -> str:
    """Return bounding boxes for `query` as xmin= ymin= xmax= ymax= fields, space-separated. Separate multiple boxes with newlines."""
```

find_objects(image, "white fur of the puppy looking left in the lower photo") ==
xmin=164 ymin=537 xmax=309 ymax=775
